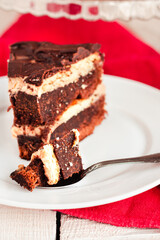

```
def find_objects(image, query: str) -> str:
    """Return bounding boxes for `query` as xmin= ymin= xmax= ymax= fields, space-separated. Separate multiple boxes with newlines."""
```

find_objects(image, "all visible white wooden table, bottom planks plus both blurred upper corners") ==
xmin=0 ymin=10 xmax=160 ymax=240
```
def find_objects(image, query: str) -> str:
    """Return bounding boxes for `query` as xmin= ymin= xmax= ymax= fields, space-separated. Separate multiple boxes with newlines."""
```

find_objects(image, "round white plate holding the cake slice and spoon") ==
xmin=0 ymin=76 xmax=160 ymax=209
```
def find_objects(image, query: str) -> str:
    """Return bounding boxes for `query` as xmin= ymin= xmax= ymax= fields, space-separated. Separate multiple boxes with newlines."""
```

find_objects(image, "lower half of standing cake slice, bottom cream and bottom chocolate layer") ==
xmin=12 ymin=84 xmax=105 ymax=159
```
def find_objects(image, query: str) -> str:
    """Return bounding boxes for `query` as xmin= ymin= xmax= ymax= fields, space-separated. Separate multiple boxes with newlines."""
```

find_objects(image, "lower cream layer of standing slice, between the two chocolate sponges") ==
xmin=11 ymin=83 xmax=105 ymax=143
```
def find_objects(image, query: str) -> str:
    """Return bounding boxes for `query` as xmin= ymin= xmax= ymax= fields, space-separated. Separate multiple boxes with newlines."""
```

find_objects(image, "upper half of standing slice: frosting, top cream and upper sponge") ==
xmin=8 ymin=42 xmax=103 ymax=127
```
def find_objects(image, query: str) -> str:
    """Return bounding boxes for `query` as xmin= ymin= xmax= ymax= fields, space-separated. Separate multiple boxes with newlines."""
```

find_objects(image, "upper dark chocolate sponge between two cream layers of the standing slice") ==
xmin=10 ymin=67 xmax=102 ymax=126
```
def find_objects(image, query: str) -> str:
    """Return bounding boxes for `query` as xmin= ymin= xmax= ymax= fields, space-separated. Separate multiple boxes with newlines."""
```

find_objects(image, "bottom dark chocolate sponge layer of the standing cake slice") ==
xmin=17 ymin=96 xmax=106 ymax=160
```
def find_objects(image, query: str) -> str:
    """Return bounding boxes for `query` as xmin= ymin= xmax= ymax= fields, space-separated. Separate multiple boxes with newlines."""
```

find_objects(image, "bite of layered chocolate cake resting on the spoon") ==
xmin=10 ymin=129 xmax=82 ymax=191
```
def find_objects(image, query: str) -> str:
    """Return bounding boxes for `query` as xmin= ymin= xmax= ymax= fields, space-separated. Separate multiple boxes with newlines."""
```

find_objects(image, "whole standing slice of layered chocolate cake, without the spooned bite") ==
xmin=8 ymin=42 xmax=106 ymax=160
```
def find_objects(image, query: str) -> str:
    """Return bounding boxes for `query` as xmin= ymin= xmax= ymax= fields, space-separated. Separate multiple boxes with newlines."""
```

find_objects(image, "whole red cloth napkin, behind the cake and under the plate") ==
xmin=0 ymin=14 xmax=160 ymax=228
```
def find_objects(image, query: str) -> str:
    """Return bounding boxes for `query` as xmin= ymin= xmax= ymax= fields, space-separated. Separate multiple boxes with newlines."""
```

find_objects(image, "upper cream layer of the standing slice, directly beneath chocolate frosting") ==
xmin=8 ymin=53 xmax=102 ymax=97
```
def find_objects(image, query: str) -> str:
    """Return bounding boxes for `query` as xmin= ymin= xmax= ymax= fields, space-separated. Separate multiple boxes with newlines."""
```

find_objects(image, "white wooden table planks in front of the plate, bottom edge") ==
xmin=0 ymin=205 xmax=160 ymax=240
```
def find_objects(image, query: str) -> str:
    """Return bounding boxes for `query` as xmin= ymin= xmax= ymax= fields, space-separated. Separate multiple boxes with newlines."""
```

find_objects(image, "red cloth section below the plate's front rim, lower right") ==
xmin=60 ymin=187 xmax=160 ymax=228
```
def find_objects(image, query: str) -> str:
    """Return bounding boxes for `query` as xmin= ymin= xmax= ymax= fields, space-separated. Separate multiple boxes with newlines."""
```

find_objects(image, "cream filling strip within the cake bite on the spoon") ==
xmin=31 ymin=144 xmax=60 ymax=185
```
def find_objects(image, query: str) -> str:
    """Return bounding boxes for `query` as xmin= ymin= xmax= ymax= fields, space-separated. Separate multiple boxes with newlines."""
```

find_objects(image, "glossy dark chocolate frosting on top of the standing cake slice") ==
xmin=8 ymin=42 xmax=100 ymax=86
